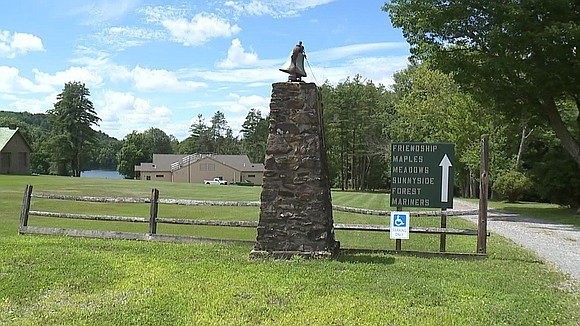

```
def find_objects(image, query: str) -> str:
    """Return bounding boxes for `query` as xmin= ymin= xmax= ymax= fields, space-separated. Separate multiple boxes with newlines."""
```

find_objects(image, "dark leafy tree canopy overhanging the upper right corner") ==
xmin=383 ymin=0 xmax=580 ymax=167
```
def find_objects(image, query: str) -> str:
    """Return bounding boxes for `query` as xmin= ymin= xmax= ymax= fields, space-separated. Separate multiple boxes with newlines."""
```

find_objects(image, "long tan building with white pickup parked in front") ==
xmin=135 ymin=154 xmax=264 ymax=185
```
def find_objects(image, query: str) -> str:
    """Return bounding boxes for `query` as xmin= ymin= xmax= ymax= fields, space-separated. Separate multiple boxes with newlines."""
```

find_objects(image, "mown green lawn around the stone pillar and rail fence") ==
xmin=0 ymin=176 xmax=580 ymax=325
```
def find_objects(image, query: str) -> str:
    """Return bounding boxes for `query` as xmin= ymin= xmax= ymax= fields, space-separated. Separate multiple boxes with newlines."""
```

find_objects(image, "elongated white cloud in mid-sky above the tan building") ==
xmin=130 ymin=66 xmax=207 ymax=92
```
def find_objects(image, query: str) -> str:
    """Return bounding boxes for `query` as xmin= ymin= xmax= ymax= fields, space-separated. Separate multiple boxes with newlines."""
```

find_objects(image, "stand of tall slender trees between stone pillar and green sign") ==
xmin=321 ymin=75 xmax=391 ymax=190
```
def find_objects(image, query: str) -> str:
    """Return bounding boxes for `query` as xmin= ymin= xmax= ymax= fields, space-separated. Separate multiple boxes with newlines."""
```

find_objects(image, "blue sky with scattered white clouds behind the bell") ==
xmin=0 ymin=0 xmax=409 ymax=140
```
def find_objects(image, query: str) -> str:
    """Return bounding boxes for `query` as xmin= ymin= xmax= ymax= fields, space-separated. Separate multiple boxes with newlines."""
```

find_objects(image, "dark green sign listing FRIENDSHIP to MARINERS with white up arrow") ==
xmin=391 ymin=143 xmax=455 ymax=208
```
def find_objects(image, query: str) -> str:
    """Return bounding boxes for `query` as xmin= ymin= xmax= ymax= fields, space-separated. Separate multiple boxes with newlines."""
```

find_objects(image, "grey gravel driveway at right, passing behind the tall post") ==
xmin=453 ymin=199 xmax=580 ymax=281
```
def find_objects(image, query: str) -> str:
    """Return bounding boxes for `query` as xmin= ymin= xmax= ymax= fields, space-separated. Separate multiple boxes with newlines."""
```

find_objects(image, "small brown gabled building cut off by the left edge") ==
xmin=0 ymin=126 xmax=32 ymax=174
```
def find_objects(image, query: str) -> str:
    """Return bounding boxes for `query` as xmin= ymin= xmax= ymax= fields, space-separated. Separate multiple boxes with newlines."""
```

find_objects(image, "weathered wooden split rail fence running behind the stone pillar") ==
xmin=19 ymin=185 xmax=488 ymax=256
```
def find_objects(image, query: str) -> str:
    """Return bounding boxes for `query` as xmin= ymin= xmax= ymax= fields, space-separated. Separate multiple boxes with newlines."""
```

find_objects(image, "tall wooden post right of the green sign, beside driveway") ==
xmin=477 ymin=135 xmax=489 ymax=254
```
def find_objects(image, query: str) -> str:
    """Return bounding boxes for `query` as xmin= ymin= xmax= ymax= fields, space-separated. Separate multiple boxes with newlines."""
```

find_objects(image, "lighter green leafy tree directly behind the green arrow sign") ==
xmin=389 ymin=64 xmax=517 ymax=197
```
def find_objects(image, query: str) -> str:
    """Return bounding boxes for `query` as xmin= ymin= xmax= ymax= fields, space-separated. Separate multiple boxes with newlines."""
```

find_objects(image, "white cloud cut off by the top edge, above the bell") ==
xmin=224 ymin=0 xmax=335 ymax=17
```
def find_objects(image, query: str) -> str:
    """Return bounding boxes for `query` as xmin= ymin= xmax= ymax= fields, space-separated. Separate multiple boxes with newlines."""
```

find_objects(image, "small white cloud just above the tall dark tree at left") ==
xmin=32 ymin=67 xmax=103 ymax=89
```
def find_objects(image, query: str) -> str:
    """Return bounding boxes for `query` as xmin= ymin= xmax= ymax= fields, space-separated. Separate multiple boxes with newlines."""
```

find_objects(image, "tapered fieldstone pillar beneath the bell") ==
xmin=250 ymin=82 xmax=340 ymax=258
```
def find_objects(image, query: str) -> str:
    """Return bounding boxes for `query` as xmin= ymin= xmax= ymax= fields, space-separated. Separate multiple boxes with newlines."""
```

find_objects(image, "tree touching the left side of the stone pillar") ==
xmin=241 ymin=108 xmax=268 ymax=163
